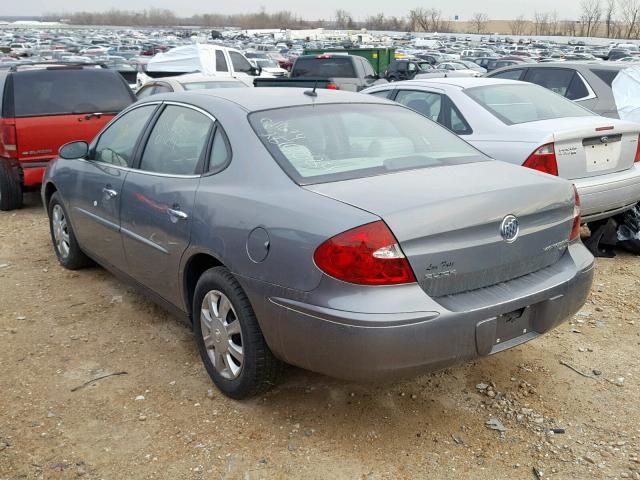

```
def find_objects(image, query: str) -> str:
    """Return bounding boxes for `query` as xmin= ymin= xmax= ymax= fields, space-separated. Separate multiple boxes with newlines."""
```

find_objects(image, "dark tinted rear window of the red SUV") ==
xmin=13 ymin=68 xmax=133 ymax=117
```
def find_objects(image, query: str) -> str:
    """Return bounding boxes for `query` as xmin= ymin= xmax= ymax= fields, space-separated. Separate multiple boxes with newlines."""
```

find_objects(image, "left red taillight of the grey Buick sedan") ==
xmin=313 ymin=221 xmax=416 ymax=285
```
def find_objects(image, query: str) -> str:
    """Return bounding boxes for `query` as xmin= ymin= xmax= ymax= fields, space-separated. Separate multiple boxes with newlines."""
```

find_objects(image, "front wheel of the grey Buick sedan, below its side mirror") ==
xmin=47 ymin=192 xmax=91 ymax=270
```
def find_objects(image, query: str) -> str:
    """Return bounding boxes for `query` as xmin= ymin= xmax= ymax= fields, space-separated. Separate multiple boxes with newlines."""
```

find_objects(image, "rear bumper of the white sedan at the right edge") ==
xmin=573 ymin=164 xmax=640 ymax=222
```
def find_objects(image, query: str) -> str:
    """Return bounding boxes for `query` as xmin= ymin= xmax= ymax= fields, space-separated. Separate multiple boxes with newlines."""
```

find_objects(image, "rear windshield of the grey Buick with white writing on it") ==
xmin=249 ymin=103 xmax=488 ymax=185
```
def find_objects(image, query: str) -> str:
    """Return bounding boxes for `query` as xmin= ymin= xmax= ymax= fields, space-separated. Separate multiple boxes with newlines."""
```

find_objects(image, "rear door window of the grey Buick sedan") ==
xmin=140 ymin=105 xmax=213 ymax=175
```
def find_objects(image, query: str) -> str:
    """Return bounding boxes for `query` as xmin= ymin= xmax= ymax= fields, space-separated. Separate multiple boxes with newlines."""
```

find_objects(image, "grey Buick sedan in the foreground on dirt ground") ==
xmin=42 ymin=88 xmax=593 ymax=398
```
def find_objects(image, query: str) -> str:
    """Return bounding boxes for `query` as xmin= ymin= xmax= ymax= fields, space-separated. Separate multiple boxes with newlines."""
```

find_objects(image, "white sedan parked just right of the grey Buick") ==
xmin=363 ymin=78 xmax=640 ymax=222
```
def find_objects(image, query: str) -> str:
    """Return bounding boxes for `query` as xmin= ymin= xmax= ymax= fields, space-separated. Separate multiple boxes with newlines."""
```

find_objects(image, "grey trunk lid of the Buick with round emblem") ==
xmin=304 ymin=161 xmax=573 ymax=297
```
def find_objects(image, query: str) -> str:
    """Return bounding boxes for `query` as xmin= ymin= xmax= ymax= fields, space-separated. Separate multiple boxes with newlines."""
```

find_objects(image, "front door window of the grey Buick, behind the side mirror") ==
xmin=93 ymin=105 xmax=156 ymax=167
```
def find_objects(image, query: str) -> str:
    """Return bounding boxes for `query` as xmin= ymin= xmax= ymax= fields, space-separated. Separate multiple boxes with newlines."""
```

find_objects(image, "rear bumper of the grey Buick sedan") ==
xmin=241 ymin=243 xmax=593 ymax=380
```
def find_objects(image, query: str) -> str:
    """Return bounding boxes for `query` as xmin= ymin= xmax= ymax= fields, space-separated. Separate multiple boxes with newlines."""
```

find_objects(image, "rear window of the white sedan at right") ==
xmin=465 ymin=84 xmax=595 ymax=125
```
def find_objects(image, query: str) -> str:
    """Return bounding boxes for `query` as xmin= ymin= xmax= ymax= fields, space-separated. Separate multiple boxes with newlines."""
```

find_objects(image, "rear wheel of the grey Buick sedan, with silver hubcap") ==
xmin=193 ymin=267 xmax=281 ymax=400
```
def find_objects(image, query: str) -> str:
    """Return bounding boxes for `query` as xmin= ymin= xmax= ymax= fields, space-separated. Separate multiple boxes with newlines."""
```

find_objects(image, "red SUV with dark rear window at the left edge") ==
xmin=0 ymin=64 xmax=136 ymax=210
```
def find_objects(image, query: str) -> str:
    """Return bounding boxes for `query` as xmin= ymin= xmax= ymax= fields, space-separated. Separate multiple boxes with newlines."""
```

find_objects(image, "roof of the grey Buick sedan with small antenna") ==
xmin=143 ymin=87 xmax=392 ymax=112
